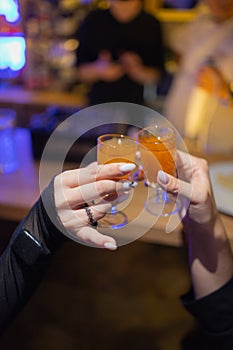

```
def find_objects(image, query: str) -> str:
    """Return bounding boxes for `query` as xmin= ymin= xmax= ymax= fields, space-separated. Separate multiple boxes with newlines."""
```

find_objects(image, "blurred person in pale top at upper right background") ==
xmin=163 ymin=0 xmax=233 ymax=135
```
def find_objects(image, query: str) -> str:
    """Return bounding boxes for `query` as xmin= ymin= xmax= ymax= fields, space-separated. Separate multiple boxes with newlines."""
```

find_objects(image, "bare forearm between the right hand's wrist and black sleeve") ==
xmin=185 ymin=215 xmax=233 ymax=299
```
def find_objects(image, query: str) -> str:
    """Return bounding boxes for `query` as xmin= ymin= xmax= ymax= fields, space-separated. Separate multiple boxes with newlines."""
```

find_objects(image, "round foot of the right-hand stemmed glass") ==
xmin=145 ymin=193 xmax=180 ymax=216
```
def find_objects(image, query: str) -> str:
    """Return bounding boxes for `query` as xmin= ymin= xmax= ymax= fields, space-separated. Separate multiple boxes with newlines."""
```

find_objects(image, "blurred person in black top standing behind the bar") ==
xmin=74 ymin=0 xmax=164 ymax=105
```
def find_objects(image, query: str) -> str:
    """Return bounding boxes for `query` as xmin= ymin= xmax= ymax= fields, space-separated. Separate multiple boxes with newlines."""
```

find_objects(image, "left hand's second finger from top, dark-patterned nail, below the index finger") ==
xmin=63 ymin=180 xmax=137 ymax=208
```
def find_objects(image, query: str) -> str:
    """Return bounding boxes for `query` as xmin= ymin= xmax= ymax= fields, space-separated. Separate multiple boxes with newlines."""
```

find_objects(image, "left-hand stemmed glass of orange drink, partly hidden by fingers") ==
xmin=97 ymin=134 xmax=137 ymax=229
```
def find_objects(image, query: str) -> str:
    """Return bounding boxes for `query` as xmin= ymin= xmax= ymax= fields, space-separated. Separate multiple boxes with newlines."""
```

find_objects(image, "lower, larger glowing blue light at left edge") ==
xmin=0 ymin=36 xmax=26 ymax=71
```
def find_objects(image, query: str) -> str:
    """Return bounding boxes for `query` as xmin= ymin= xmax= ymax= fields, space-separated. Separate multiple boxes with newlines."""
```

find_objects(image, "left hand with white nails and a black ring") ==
xmin=54 ymin=163 xmax=136 ymax=250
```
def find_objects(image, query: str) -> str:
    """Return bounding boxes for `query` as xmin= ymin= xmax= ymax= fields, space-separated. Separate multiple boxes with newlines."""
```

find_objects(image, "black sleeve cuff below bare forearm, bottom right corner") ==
xmin=181 ymin=278 xmax=233 ymax=350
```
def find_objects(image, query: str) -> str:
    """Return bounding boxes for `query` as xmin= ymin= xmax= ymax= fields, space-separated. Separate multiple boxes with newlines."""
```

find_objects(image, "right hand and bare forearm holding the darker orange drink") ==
xmin=157 ymin=152 xmax=233 ymax=299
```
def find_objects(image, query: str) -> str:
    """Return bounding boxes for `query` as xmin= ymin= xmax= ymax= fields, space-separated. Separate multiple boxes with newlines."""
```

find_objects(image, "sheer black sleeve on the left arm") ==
xmin=0 ymin=182 xmax=67 ymax=331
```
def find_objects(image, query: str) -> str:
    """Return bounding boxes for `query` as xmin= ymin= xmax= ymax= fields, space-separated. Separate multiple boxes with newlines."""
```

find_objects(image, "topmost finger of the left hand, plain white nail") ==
xmin=60 ymin=163 xmax=136 ymax=188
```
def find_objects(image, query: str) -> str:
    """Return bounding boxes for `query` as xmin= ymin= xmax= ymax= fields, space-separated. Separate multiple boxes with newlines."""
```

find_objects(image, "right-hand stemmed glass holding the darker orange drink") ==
xmin=138 ymin=124 xmax=180 ymax=216
